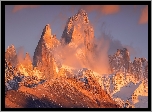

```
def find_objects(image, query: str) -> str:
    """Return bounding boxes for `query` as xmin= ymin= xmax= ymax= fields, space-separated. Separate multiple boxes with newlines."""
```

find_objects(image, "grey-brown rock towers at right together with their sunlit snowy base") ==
xmin=103 ymin=48 xmax=148 ymax=104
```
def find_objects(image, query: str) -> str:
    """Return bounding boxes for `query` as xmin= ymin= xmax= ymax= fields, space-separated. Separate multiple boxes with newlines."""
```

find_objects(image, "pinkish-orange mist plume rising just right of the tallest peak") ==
xmin=91 ymin=35 xmax=110 ymax=74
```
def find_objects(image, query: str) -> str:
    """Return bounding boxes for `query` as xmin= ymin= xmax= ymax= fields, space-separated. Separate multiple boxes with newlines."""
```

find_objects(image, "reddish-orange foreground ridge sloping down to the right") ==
xmin=5 ymin=70 xmax=120 ymax=108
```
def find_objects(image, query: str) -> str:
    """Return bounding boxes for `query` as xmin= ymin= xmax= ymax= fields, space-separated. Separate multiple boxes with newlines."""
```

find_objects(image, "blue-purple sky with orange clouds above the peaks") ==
xmin=5 ymin=5 xmax=148 ymax=59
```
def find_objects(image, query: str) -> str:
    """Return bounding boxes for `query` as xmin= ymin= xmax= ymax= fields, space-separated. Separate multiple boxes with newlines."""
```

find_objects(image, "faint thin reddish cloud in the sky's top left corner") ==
xmin=12 ymin=5 xmax=39 ymax=13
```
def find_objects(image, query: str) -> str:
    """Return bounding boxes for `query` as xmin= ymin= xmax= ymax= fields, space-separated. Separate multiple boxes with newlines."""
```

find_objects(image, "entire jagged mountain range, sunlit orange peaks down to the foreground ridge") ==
xmin=5 ymin=9 xmax=148 ymax=108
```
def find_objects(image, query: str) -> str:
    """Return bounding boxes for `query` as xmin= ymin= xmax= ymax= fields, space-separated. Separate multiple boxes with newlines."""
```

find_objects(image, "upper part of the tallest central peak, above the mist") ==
xmin=62 ymin=9 xmax=94 ymax=47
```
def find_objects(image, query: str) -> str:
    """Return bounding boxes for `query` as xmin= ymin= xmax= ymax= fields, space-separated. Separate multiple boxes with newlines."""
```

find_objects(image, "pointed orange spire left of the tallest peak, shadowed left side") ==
xmin=33 ymin=24 xmax=59 ymax=79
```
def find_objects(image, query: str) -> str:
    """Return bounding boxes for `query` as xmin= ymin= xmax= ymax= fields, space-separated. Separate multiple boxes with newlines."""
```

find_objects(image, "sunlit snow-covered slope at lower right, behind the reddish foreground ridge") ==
xmin=63 ymin=67 xmax=148 ymax=108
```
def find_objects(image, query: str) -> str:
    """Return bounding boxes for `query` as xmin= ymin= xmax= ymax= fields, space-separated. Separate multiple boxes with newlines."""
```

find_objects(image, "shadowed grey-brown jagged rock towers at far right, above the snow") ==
xmin=109 ymin=48 xmax=148 ymax=80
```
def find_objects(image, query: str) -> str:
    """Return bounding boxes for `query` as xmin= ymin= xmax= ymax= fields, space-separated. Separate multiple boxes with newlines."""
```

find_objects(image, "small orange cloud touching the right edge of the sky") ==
xmin=138 ymin=6 xmax=148 ymax=24
